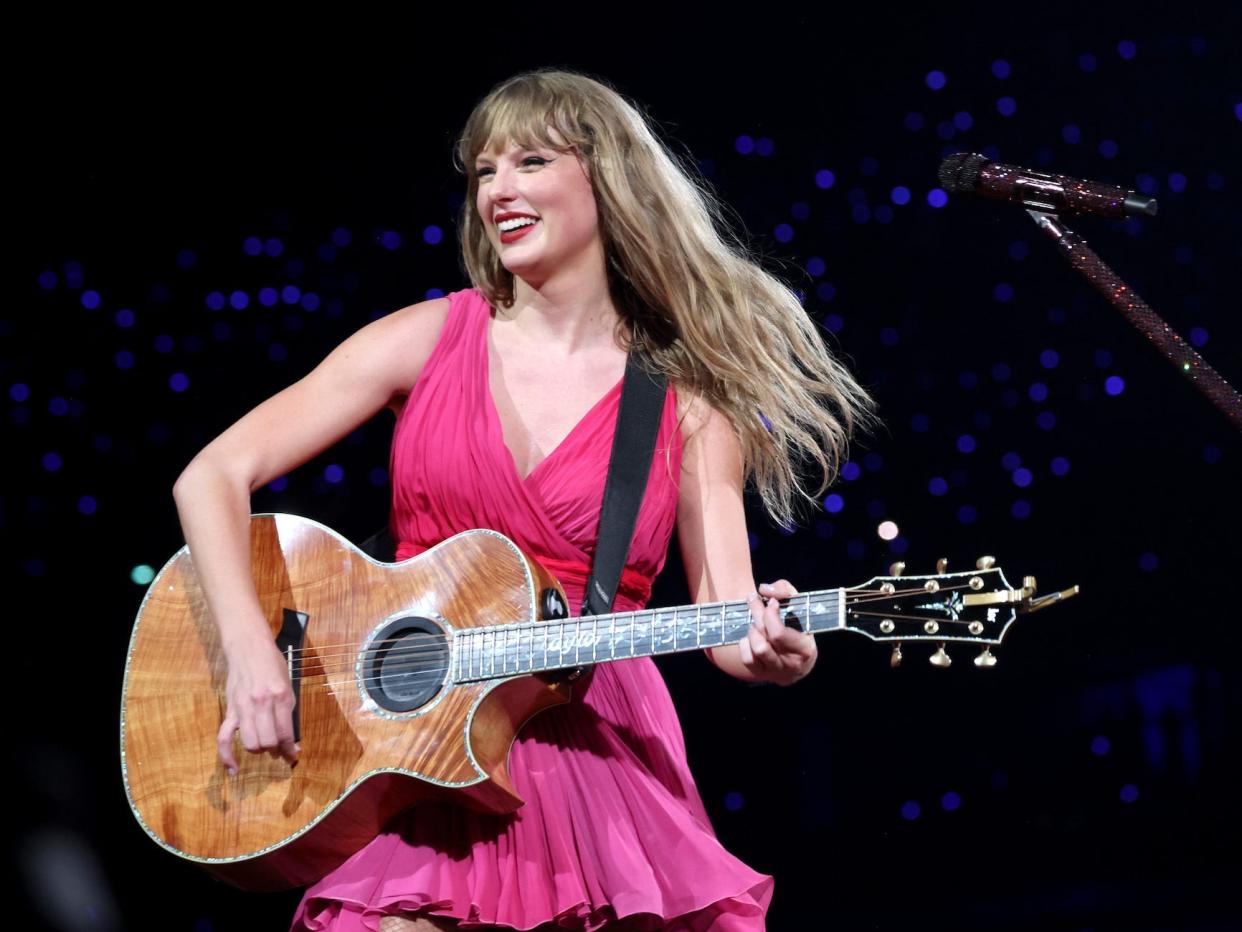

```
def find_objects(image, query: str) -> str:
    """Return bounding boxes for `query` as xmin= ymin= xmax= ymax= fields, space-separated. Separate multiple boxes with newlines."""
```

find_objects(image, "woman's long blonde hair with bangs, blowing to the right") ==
xmin=456 ymin=71 xmax=872 ymax=523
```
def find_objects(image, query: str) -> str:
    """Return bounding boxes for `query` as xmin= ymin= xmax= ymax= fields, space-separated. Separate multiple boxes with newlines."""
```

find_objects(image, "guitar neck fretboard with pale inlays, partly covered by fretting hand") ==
xmin=452 ymin=589 xmax=846 ymax=683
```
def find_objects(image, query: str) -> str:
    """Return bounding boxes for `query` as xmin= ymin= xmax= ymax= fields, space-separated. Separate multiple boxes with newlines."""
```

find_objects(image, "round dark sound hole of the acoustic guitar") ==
xmin=363 ymin=618 xmax=448 ymax=712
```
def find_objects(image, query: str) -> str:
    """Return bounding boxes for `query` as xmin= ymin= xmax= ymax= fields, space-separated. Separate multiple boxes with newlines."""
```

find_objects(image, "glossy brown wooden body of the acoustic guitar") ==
xmin=120 ymin=514 xmax=569 ymax=890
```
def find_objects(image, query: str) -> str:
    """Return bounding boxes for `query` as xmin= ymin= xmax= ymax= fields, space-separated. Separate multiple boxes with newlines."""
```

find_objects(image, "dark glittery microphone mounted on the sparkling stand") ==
xmin=940 ymin=152 xmax=1156 ymax=219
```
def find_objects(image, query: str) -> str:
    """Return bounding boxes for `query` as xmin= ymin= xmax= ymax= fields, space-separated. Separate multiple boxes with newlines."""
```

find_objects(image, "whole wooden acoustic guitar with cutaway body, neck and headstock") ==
xmin=120 ymin=514 xmax=1077 ymax=890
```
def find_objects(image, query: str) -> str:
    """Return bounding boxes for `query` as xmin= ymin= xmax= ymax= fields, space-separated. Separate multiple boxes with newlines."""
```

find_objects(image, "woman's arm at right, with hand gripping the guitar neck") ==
xmin=677 ymin=399 xmax=816 ymax=685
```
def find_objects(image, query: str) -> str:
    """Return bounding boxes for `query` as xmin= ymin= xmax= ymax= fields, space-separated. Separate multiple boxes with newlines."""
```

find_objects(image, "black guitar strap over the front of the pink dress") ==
xmin=582 ymin=352 xmax=667 ymax=615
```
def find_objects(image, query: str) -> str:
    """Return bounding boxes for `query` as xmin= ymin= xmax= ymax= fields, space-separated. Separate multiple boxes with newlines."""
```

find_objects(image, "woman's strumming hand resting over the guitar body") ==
xmin=216 ymin=641 xmax=302 ymax=774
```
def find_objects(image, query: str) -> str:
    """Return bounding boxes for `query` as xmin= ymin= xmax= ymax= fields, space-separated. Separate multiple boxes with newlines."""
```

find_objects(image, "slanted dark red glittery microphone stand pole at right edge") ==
xmin=1026 ymin=209 xmax=1242 ymax=431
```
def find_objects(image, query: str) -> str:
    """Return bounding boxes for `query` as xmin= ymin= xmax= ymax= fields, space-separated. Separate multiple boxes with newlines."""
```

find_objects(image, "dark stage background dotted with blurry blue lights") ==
xmin=12 ymin=4 xmax=1242 ymax=932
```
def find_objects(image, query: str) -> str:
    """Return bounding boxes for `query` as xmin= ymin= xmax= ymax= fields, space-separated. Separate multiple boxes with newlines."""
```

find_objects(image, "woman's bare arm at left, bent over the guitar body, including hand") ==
xmin=173 ymin=298 xmax=448 ymax=772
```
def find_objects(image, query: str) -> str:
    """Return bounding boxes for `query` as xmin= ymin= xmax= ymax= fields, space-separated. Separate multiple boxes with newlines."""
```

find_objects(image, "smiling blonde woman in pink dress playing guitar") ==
xmin=174 ymin=72 xmax=869 ymax=932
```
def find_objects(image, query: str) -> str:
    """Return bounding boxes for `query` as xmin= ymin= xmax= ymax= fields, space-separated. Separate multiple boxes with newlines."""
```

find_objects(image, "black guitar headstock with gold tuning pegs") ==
xmin=846 ymin=557 xmax=1078 ymax=669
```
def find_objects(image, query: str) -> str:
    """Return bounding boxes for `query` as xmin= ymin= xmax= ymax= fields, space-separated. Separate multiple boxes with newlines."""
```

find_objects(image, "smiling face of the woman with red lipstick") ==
xmin=474 ymin=136 xmax=604 ymax=287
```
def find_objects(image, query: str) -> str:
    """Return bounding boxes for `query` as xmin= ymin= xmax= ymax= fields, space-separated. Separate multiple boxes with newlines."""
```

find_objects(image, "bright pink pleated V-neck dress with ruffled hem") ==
xmin=293 ymin=290 xmax=773 ymax=932
